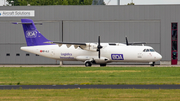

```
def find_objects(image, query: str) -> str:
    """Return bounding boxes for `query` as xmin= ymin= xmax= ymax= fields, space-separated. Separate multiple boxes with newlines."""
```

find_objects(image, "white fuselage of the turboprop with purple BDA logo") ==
xmin=21 ymin=43 xmax=162 ymax=63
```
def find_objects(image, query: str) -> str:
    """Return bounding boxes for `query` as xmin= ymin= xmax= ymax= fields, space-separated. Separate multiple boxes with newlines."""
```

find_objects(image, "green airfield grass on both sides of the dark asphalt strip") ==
xmin=0 ymin=67 xmax=180 ymax=101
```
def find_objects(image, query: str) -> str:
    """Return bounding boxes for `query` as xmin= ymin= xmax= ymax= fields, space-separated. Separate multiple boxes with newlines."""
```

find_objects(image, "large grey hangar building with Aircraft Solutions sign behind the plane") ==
xmin=0 ymin=5 xmax=180 ymax=64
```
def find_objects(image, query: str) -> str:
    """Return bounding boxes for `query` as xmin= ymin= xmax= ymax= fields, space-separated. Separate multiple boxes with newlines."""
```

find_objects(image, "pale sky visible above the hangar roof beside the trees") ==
xmin=0 ymin=0 xmax=180 ymax=6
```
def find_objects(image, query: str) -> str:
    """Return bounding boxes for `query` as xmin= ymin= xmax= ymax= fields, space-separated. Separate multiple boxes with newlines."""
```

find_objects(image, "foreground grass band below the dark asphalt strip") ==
xmin=0 ymin=89 xmax=180 ymax=101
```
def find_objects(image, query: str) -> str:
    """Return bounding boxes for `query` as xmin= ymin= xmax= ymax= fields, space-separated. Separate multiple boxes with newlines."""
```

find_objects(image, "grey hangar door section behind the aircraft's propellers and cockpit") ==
xmin=63 ymin=20 xmax=160 ymax=64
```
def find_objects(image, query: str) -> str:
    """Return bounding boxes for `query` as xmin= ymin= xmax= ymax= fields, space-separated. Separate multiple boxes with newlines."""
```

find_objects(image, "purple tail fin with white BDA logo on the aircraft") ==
xmin=21 ymin=19 xmax=52 ymax=46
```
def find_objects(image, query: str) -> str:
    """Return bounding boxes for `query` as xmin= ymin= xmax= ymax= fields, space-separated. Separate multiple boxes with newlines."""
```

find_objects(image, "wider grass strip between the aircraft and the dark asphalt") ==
xmin=0 ymin=67 xmax=180 ymax=85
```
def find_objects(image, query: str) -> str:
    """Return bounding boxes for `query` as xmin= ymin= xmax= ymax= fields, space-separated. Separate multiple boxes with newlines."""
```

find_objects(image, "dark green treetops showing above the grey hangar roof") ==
xmin=7 ymin=0 xmax=93 ymax=6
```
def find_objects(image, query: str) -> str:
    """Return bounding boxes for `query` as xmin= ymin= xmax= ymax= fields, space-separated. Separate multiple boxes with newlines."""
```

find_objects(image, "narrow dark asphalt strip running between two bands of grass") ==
xmin=0 ymin=85 xmax=180 ymax=89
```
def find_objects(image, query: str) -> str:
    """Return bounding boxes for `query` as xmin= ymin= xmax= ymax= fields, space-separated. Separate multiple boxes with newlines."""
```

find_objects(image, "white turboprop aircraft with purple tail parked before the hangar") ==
xmin=13 ymin=19 xmax=162 ymax=66
